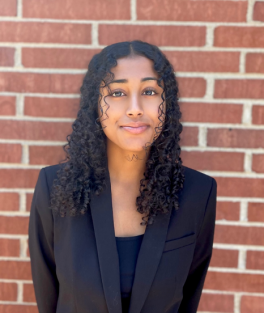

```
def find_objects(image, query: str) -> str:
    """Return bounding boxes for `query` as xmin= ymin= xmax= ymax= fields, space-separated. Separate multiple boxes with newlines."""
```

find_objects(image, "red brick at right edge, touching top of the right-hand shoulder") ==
xmin=215 ymin=176 xmax=264 ymax=198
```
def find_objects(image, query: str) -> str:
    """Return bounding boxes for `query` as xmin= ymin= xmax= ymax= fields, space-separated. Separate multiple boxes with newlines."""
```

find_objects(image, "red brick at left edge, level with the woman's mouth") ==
xmin=0 ymin=120 xmax=72 ymax=141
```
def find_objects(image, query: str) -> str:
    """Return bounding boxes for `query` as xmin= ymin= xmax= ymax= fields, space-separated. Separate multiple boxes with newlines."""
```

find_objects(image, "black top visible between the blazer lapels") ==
xmin=115 ymin=234 xmax=144 ymax=313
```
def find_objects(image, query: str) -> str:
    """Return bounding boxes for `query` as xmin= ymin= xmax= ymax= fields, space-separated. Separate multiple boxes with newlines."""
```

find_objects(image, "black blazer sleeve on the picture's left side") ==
xmin=28 ymin=168 xmax=59 ymax=313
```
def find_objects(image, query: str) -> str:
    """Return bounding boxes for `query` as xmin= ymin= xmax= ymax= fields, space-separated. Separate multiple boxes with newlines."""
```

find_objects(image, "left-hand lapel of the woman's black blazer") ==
xmin=90 ymin=170 xmax=122 ymax=313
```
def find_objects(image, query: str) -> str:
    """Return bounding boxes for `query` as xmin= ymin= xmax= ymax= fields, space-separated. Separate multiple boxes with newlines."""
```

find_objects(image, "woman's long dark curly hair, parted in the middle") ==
xmin=50 ymin=40 xmax=185 ymax=225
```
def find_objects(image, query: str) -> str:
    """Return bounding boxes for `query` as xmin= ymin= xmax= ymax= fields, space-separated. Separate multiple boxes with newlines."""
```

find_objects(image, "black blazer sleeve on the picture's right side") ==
xmin=179 ymin=178 xmax=217 ymax=313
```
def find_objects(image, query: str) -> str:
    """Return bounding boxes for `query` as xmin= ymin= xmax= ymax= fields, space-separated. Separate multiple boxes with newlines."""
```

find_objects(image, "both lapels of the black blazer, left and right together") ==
xmin=90 ymin=167 xmax=171 ymax=313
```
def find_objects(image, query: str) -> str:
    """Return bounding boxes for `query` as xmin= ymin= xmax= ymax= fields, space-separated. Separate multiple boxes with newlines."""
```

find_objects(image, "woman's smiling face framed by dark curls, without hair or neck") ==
xmin=98 ymin=56 xmax=165 ymax=152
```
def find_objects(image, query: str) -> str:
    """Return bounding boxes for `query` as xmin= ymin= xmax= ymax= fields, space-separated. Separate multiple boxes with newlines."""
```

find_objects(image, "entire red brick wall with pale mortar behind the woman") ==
xmin=0 ymin=0 xmax=264 ymax=313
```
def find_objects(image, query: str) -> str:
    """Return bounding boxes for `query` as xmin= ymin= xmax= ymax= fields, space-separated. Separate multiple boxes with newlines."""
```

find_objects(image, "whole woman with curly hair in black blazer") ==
xmin=29 ymin=40 xmax=217 ymax=313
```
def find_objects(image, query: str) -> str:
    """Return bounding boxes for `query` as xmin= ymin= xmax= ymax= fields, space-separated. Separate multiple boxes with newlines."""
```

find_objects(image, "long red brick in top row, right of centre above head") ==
xmin=137 ymin=0 xmax=247 ymax=22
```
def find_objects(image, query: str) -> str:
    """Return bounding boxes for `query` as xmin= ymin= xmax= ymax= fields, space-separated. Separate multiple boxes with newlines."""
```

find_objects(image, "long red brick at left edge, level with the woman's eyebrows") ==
xmin=0 ymin=72 xmax=84 ymax=94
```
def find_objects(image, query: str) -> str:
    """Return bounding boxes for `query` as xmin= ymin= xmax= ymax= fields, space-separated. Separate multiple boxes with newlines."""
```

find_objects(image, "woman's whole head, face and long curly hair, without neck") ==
xmin=52 ymin=40 xmax=184 ymax=223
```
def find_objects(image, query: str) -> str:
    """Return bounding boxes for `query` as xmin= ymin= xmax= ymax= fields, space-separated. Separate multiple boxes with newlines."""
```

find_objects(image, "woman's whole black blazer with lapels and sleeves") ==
xmin=28 ymin=164 xmax=217 ymax=313
